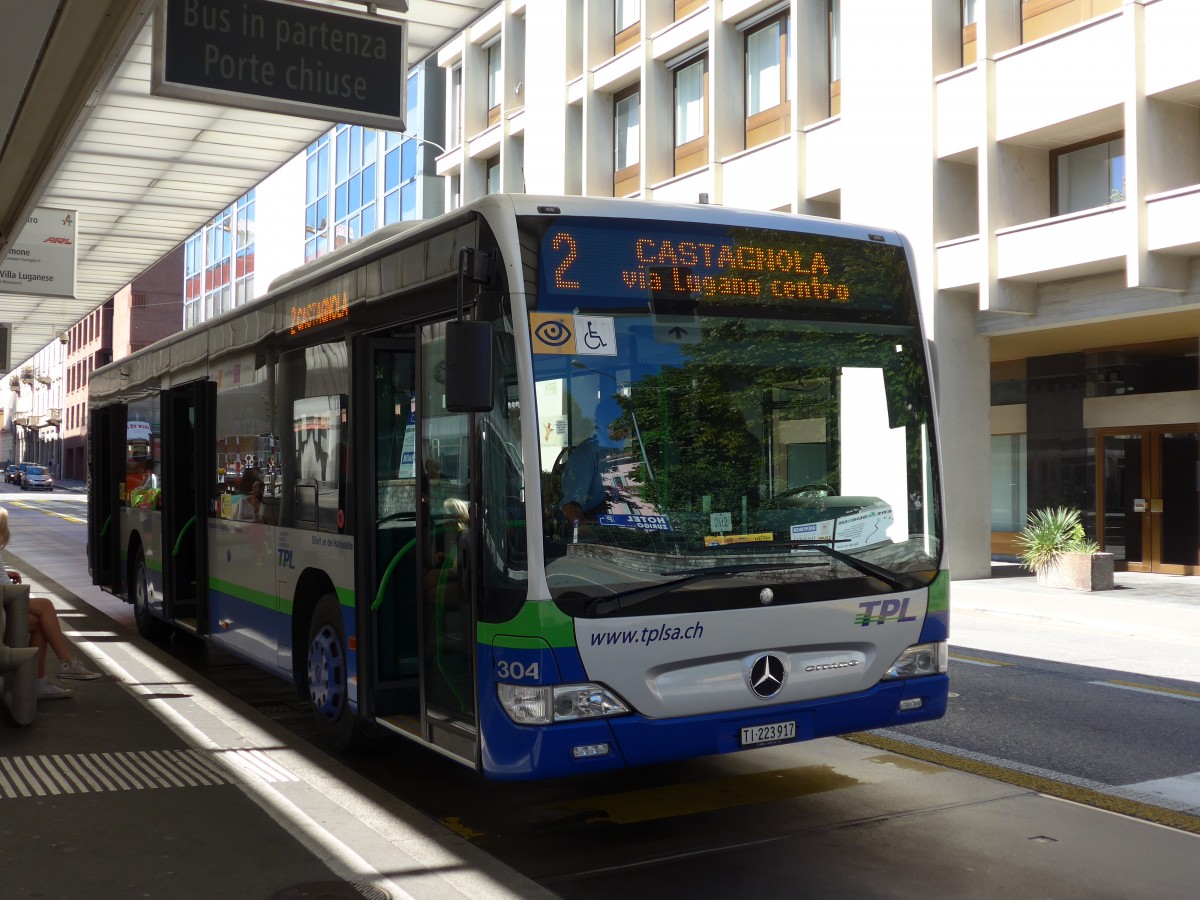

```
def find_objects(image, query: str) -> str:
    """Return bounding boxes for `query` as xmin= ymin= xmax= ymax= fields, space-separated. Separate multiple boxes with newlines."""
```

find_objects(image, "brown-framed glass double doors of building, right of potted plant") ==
xmin=1096 ymin=425 xmax=1200 ymax=575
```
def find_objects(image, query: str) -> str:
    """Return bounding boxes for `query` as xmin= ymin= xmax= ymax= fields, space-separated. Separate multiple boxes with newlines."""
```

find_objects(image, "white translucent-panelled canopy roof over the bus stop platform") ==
xmin=0 ymin=0 xmax=496 ymax=374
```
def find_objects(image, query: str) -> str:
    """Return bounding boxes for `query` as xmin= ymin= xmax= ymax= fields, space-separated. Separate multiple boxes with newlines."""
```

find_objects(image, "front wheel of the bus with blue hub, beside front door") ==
xmin=308 ymin=594 xmax=358 ymax=750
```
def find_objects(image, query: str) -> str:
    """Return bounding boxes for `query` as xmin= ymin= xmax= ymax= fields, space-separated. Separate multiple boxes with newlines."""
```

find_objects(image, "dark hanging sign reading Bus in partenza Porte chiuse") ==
xmin=152 ymin=0 xmax=408 ymax=131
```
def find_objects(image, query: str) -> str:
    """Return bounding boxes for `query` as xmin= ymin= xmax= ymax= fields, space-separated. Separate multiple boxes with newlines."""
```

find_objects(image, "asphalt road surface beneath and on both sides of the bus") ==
xmin=0 ymin=494 xmax=1200 ymax=898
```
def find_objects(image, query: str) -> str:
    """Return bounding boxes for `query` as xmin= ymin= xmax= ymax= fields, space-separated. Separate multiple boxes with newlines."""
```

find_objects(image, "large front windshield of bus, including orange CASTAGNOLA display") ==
xmin=529 ymin=218 xmax=941 ymax=614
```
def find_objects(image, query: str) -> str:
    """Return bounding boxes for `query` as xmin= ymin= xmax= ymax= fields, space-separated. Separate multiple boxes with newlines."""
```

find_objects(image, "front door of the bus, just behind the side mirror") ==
xmin=356 ymin=325 xmax=479 ymax=766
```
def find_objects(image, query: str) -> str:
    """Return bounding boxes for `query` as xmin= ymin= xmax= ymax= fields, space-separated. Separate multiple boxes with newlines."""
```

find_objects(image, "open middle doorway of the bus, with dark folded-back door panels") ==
xmin=161 ymin=380 xmax=216 ymax=635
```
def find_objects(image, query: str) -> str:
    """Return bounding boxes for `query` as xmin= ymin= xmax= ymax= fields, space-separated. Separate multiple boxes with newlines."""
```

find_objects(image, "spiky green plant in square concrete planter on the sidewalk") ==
xmin=1016 ymin=506 xmax=1114 ymax=590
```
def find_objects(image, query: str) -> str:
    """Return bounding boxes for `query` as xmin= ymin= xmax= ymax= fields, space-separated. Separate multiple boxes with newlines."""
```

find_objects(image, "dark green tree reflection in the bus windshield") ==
xmin=622 ymin=318 xmax=929 ymax=525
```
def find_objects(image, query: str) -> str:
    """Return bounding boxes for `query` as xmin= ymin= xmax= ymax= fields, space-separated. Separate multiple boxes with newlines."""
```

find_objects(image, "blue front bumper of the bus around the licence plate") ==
xmin=479 ymin=644 xmax=949 ymax=780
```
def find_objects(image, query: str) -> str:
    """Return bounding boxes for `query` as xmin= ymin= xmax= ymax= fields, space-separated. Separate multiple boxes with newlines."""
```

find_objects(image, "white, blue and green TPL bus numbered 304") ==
xmin=89 ymin=196 xmax=949 ymax=779
